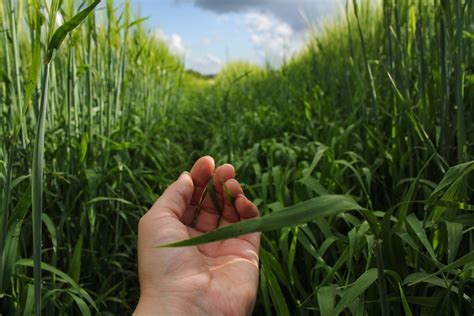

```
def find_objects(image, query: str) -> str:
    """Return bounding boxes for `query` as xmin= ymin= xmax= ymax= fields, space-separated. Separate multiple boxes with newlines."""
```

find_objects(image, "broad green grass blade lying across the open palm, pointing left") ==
xmin=158 ymin=195 xmax=363 ymax=247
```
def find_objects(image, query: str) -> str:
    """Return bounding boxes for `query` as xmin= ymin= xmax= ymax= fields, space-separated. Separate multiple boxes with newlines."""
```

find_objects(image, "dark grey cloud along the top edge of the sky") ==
xmin=175 ymin=0 xmax=337 ymax=31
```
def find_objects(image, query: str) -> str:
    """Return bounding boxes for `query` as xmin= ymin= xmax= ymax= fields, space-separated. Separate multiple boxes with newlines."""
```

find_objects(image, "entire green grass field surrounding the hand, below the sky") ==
xmin=0 ymin=0 xmax=474 ymax=315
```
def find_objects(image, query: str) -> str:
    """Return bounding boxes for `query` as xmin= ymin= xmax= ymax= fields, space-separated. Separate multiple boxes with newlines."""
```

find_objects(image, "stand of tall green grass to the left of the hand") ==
xmin=0 ymin=1 xmax=182 ymax=314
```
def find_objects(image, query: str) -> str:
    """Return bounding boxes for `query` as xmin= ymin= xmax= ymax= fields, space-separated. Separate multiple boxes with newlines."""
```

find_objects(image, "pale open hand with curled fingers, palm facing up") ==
xmin=134 ymin=156 xmax=260 ymax=315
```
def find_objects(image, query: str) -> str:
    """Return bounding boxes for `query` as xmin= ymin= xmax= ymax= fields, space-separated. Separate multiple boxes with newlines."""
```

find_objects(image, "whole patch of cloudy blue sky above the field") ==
xmin=132 ymin=0 xmax=340 ymax=74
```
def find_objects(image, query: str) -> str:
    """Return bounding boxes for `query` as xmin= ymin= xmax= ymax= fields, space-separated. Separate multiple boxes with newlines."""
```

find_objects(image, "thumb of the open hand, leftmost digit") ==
xmin=150 ymin=171 xmax=194 ymax=220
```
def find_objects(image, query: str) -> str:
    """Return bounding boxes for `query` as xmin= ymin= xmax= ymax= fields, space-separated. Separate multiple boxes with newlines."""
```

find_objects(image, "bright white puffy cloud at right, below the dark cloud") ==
xmin=244 ymin=12 xmax=303 ymax=66
